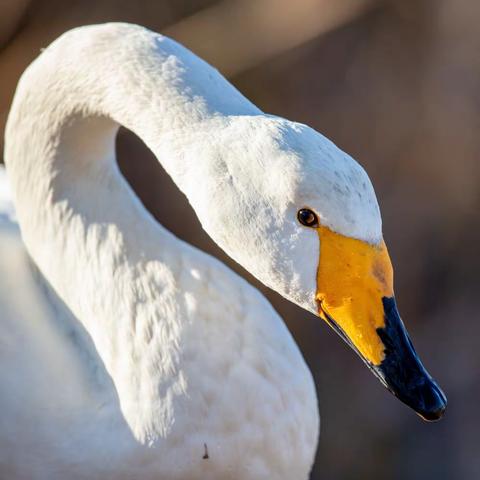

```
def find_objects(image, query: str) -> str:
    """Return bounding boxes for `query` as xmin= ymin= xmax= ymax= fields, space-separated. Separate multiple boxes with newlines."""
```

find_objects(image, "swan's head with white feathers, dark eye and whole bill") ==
xmin=183 ymin=115 xmax=446 ymax=420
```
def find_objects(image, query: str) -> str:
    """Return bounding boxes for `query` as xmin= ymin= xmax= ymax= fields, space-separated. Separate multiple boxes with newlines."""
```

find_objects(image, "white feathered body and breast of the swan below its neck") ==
xmin=0 ymin=163 xmax=318 ymax=479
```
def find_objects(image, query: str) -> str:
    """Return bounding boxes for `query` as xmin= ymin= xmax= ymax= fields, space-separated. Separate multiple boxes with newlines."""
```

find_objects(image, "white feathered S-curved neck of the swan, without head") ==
xmin=5 ymin=24 xmax=259 ymax=438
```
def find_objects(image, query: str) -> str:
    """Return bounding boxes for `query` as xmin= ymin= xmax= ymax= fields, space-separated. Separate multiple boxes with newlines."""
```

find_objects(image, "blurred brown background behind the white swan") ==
xmin=0 ymin=0 xmax=480 ymax=480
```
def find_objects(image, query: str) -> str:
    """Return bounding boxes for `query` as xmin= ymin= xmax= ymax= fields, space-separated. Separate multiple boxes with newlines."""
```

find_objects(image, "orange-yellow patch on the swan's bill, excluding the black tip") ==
xmin=316 ymin=226 xmax=393 ymax=365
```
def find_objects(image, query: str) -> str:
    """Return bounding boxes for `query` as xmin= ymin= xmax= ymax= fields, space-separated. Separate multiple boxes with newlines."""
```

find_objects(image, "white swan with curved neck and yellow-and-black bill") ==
xmin=0 ymin=23 xmax=446 ymax=480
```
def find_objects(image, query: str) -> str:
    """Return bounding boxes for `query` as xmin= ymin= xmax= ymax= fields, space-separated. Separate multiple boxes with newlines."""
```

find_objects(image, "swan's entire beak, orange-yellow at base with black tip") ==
xmin=316 ymin=226 xmax=447 ymax=421
